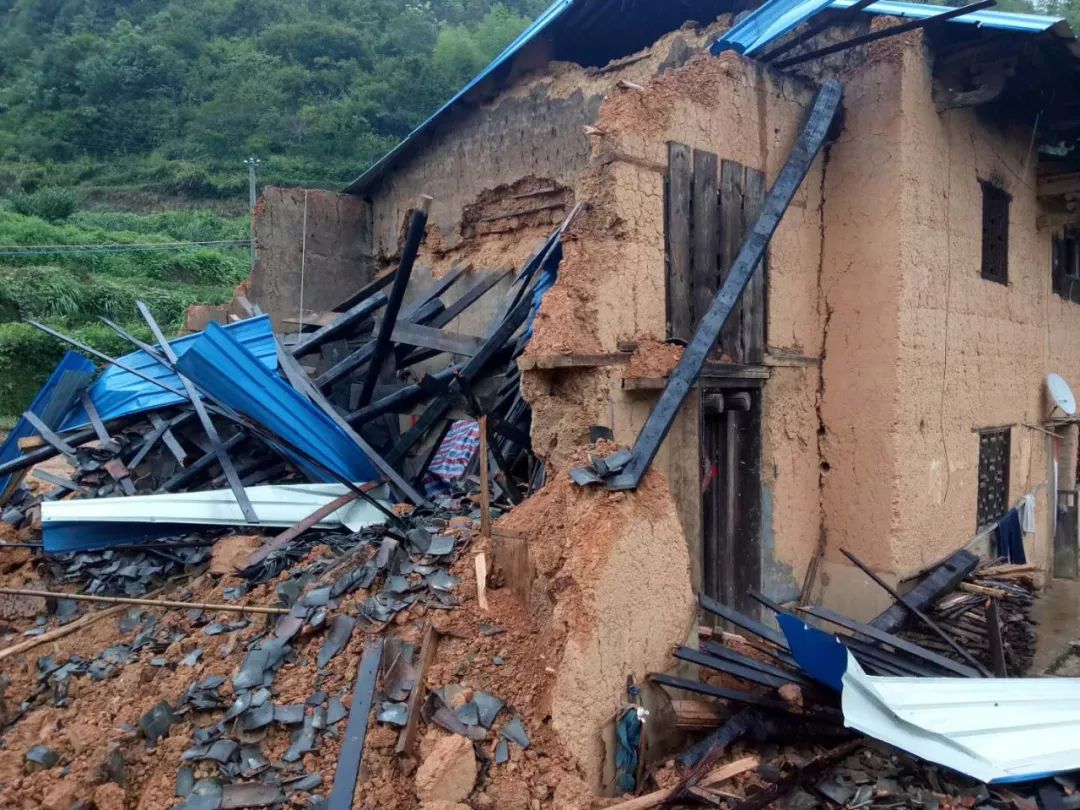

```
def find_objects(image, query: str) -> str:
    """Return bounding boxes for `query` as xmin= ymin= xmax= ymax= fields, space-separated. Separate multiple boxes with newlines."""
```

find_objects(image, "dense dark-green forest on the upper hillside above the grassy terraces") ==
xmin=0 ymin=0 xmax=546 ymax=199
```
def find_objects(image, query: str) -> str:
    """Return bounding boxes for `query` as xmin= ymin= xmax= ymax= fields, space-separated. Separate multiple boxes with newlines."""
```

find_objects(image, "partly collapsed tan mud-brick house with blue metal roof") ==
xmin=234 ymin=0 xmax=1080 ymax=785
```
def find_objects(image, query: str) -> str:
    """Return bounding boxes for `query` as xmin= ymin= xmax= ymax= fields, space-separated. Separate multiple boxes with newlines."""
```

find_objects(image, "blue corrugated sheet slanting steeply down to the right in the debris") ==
xmin=177 ymin=323 xmax=379 ymax=483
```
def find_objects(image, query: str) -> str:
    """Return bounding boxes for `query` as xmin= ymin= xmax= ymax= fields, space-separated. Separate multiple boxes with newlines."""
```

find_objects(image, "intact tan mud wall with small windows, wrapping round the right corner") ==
xmin=821 ymin=35 xmax=1067 ymax=618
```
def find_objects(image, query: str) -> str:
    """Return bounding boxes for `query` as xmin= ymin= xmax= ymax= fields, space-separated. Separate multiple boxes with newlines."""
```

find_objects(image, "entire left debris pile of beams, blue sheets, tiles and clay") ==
xmin=0 ymin=203 xmax=600 ymax=810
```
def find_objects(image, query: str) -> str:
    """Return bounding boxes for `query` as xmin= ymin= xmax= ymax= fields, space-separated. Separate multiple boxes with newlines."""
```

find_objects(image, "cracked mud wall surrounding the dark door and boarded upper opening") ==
xmin=525 ymin=54 xmax=823 ymax=598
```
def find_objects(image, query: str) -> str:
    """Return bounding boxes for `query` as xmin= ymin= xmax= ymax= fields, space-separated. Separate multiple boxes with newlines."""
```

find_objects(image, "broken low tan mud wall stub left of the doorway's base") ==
xmin=500 ymin=468 xmax=696 ymax=794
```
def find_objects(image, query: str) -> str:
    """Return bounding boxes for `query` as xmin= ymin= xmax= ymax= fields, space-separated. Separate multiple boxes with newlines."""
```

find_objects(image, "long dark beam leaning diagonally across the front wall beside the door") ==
xmin=591 ymin=80 xmax=843 ymax=490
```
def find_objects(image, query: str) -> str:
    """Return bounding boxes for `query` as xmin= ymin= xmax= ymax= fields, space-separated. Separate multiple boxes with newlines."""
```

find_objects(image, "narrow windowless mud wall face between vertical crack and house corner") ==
xmin=819 ymin=50 xmax=904 ymax=617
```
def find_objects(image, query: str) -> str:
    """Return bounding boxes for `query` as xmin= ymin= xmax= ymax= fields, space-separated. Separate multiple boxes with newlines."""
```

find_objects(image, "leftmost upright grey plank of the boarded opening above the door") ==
xmin=664 ymin=141 xmax=693 ymax=340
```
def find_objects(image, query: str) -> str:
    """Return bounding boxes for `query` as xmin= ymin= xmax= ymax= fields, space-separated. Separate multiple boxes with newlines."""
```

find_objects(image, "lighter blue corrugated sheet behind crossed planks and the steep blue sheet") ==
xmin=63 ymin=315 xmax=278 ymax=430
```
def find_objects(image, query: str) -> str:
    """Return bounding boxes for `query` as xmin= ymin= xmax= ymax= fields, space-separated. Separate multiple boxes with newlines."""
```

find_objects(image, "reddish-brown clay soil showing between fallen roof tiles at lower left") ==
xmin=0 ymin=509 xmax=589 ymax=810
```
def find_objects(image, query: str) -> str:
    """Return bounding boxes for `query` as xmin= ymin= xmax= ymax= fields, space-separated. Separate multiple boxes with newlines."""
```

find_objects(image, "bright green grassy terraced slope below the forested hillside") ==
xmin=0 ymin=203 xmax=249 ymax=419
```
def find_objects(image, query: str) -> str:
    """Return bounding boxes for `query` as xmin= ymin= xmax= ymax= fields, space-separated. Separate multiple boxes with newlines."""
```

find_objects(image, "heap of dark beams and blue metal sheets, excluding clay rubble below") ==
xmin=0 ymin=198 xmax=573 ymax=553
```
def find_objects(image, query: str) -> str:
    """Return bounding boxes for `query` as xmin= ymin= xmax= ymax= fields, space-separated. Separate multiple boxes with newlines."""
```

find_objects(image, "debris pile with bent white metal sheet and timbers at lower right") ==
xmin=617 ymin=552 xmax=1080 ymax=810
